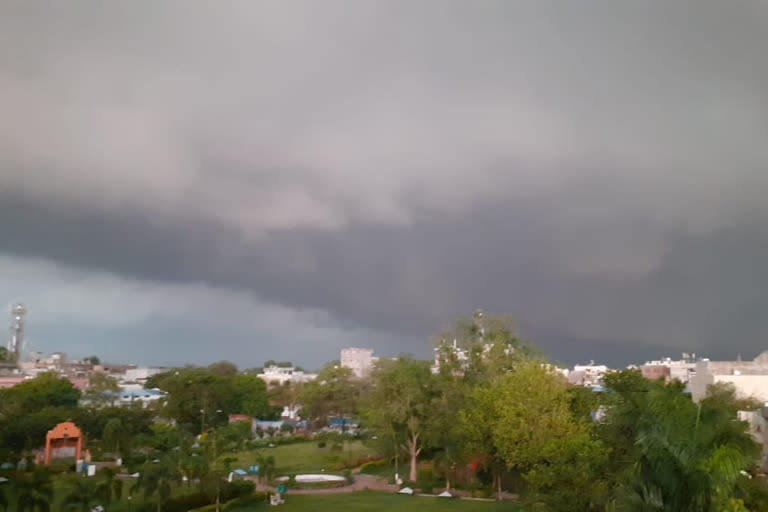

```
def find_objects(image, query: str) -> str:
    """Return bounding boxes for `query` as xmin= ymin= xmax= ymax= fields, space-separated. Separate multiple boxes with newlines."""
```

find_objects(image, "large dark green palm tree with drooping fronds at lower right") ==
xmin=599 ymin=371 xmax=759 ymax=512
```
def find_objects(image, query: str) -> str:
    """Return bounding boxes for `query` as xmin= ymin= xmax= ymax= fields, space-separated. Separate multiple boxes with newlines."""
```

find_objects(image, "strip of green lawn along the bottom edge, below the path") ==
xmin=230 ymin=492 xmax=520 ymax=512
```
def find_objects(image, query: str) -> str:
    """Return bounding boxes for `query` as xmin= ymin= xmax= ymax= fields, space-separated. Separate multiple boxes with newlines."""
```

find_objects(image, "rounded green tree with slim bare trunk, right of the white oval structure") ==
xmin=364 ymin=357 xmax=434 ymax=481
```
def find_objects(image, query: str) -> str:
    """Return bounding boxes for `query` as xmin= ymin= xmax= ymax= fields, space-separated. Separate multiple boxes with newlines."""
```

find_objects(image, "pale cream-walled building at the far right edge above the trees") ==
xmin=690 ymin=351 xmax=768 ymax=403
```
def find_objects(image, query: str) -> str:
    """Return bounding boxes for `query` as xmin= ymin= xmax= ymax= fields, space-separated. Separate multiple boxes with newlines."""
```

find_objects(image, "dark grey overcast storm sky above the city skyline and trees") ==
xmin=0 ymin=0 xmax=768 ymax=367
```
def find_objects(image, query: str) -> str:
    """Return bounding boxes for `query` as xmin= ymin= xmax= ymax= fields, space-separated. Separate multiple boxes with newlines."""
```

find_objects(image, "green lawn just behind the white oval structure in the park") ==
xmin=226 ymin=441 xmax=376 ymax=475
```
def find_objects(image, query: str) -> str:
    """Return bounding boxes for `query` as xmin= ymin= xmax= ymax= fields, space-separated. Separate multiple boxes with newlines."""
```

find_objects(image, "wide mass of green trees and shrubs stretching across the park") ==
xmin=0 ymin=314 xmax=768 ymax=512
